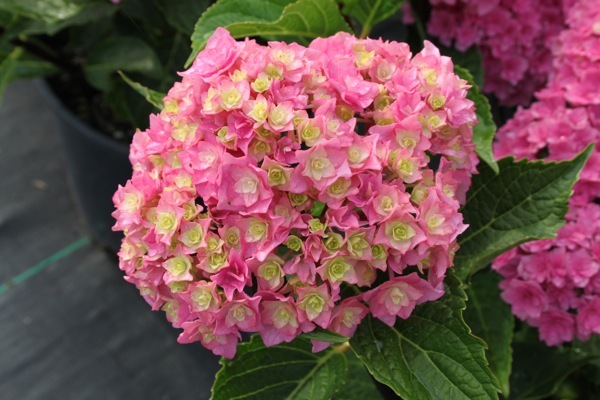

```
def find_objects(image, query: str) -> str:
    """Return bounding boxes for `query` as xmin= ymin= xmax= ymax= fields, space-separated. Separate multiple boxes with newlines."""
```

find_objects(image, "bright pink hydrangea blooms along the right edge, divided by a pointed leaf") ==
xmin=493 ymin=0 xmax=600 ymax=345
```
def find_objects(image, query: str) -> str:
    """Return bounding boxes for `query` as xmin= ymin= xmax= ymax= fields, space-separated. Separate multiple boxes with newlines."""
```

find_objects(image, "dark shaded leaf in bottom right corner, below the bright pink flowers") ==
xmin=509 ymin=342 xmax=590 ymax=400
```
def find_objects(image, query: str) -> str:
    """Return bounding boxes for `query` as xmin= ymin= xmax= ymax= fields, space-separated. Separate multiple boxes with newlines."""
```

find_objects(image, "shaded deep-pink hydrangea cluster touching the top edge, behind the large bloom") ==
xmin=427 ymin=0 xmax=565 ymax=105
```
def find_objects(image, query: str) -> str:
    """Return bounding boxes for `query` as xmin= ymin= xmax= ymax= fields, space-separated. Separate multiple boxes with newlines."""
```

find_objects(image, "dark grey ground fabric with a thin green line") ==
xmin=0 ymin=82 xmax=218 ymax=400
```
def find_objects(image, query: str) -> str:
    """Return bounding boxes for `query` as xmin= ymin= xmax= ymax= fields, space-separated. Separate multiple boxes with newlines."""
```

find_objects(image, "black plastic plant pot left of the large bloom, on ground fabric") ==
xmin=37 ymin=80 xmax=131 ymax=252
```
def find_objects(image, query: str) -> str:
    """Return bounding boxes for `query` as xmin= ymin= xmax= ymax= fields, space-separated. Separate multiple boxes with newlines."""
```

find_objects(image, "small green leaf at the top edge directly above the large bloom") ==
xmin=340 ymin=0 xmax=404 ymax=38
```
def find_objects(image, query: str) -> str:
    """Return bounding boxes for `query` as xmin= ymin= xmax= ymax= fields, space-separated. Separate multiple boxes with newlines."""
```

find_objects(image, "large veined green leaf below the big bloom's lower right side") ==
xmin=350 ymin=274 xmax=498 ymax=400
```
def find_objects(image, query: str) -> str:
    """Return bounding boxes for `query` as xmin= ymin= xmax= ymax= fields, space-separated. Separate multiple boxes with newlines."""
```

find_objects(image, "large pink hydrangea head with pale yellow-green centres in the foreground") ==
xmin=113 ymin=28 xmax=477 ymax=357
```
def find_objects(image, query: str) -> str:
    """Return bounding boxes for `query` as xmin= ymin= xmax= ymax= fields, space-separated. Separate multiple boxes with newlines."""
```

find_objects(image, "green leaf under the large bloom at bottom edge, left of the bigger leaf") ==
xmin=212 ymin=335 xmax=347 ymax=400
